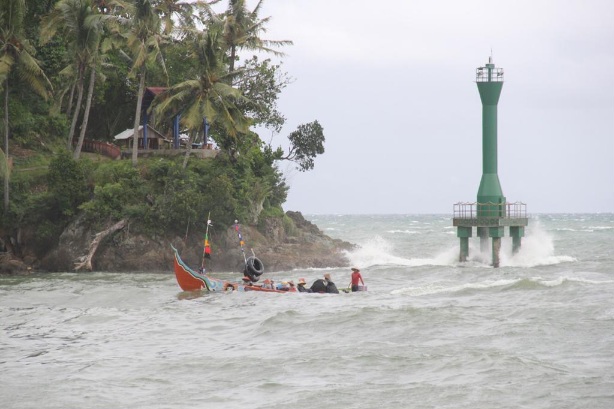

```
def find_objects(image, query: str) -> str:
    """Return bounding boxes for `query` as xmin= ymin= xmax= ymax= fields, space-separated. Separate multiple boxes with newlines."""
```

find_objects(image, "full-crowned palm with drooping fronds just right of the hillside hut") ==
xmin=154 ymin=31 xmax=249 ymax=167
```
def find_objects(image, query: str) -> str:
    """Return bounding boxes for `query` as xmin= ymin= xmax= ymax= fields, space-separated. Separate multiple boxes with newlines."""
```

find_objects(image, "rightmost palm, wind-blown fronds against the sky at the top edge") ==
xmin=222 ymin=0 xmax=292 ymax=72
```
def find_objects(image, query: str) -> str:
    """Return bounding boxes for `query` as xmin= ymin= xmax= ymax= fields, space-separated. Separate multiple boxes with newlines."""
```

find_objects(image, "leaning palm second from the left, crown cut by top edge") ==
xmin=41 ymin=0 xmax=111 ymax=159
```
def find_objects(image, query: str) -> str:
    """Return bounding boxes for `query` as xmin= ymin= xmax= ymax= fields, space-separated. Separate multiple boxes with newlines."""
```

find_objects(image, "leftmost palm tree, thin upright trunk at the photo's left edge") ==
xmin=0 ymin=0 xmax=51 ymax=214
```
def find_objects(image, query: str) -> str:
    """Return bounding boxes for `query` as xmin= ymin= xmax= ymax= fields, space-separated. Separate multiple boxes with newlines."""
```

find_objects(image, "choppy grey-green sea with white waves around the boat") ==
xmin=0 ymin=214 xmax=614 ymax=409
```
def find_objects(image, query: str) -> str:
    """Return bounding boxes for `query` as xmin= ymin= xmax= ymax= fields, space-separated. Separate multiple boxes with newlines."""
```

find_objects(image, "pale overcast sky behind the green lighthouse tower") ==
xmin=237 ymin=0 xmax=614 ymax=214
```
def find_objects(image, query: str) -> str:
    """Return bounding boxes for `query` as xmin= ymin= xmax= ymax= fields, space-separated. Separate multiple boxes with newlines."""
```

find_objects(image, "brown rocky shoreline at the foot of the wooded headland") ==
xmin=0 ymin=212 xmax=354 ymax=273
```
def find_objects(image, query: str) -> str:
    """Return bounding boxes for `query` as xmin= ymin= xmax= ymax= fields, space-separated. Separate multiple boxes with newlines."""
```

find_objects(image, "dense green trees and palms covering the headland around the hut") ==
xmin=0 ymin=0 xmax=324 ymax=255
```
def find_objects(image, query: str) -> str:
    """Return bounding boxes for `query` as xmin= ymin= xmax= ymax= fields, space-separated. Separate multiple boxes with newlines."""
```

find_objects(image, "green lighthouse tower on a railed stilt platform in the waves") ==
xmin=453 ymin=57 xmax=529 ymax=267
